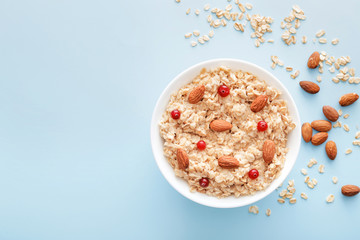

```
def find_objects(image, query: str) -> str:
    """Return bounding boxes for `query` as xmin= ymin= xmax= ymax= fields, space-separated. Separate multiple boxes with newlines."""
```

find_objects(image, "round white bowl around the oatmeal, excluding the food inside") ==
xmin=151 ymin=59 xmax=301 ymax=208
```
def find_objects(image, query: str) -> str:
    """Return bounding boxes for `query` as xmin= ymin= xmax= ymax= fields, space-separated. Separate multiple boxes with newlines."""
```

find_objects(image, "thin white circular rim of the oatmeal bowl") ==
xmin=150 ymin=58 xmax=301 ymax=208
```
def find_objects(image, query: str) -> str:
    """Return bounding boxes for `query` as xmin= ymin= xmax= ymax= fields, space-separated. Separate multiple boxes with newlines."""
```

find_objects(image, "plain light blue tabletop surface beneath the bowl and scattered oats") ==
xmin=0 ymin=0 xmax=360 ymax=240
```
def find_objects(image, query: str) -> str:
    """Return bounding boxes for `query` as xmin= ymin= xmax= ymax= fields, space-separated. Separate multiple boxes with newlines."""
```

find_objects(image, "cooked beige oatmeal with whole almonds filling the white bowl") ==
xmin=160 ymin=67 xmax=295 ymax=198
